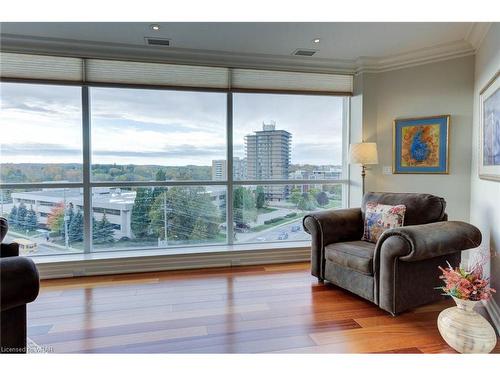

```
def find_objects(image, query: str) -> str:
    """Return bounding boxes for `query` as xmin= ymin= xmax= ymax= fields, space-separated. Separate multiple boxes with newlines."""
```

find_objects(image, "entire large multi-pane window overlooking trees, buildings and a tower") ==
xmin=0 ymin=77 xmax=348 ymax=255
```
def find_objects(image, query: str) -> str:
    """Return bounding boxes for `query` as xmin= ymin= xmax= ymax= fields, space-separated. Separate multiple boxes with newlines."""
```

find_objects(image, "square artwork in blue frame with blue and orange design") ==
xmin=392 ymin=115 xmax=450 ymax=174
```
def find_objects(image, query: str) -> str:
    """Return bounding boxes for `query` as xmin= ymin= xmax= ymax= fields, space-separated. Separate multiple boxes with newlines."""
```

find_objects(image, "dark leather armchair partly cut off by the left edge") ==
xmin=0 ymin=218 xmax=40 ymax=353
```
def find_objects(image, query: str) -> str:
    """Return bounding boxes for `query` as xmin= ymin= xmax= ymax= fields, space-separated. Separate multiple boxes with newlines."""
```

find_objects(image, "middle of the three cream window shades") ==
xmin=85 ymin=59 xmax=229 ymax=89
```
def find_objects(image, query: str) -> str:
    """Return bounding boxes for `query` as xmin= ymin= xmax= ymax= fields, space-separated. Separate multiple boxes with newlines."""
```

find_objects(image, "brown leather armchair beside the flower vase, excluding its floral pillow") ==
xmin=303 ymin=192 xmax=481 ymax=315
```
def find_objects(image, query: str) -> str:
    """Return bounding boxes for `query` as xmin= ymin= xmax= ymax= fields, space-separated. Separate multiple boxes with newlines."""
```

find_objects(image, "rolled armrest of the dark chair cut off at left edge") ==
xmin=0 ymin=257 xmax=40 ymax=311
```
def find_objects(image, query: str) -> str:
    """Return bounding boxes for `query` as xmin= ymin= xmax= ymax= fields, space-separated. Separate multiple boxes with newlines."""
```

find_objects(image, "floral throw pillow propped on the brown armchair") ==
xmin=361 ymin=202 xmax=406 ymax=242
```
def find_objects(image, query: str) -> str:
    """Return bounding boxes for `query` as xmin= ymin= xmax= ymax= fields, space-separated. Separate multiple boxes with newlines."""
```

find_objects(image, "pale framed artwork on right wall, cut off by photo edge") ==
xmin=478 ymin=71 xmax=500 ymax=181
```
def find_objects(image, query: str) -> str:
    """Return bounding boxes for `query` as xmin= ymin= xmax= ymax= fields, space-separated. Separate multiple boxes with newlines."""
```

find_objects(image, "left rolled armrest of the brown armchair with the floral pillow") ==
xmin=302 ymin=208 xmax=363 ymax=279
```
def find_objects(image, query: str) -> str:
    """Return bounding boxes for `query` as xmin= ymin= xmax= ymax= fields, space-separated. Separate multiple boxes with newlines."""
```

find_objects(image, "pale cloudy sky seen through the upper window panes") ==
xmin=0 ymin=83 xmax=342 ymax=165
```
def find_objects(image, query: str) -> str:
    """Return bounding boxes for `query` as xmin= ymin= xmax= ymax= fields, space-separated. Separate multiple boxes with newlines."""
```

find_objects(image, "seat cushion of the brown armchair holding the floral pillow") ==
xmin=325 ymin=241 xmax=375 ymax=275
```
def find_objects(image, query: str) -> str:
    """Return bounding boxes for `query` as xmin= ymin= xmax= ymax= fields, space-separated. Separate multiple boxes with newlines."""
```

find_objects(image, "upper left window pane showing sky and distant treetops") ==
xmin=0 ymin=83 xmax=82 ymax=183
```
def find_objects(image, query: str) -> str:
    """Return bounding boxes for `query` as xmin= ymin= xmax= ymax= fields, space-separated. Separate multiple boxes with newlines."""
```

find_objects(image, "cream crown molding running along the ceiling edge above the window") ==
xmin=1 ymin=32 xmax=482 ymax=74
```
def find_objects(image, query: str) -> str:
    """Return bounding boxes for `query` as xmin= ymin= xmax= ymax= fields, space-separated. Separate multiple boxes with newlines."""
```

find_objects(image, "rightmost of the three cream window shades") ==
xmin=231 ymin=69 xmax=352 ymax=94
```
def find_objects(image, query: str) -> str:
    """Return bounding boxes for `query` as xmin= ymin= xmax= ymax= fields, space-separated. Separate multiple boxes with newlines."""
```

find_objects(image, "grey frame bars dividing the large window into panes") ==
xmin=0 ymin=78 xmax=351 ymax=258
